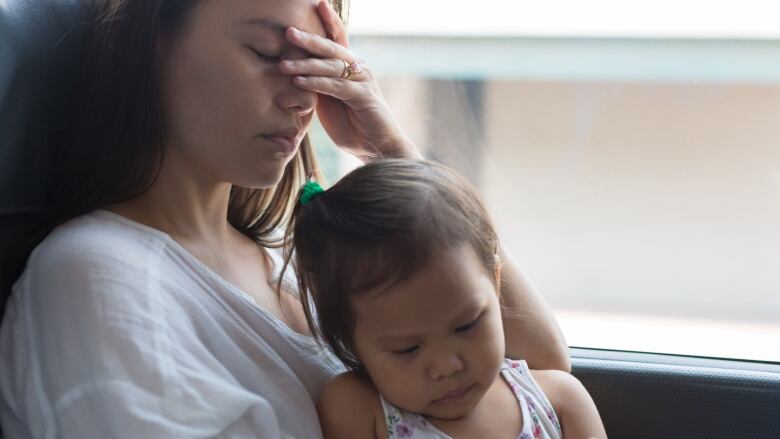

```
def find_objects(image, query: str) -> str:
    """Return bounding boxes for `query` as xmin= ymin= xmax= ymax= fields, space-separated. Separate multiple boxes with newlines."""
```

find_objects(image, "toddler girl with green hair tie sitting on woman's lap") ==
xmin=288 ymin=160 xmax=606 ymax=439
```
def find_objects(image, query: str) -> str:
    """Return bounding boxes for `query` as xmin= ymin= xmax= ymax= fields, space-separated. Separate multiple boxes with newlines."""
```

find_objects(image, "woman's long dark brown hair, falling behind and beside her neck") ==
xmin=1 ymin=0 xmax=346 ymax=308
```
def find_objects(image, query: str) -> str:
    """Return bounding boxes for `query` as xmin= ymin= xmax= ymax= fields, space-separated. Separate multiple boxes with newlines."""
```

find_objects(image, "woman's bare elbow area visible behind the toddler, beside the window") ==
xmin=501 ymin=249 xmax=571 ymax=372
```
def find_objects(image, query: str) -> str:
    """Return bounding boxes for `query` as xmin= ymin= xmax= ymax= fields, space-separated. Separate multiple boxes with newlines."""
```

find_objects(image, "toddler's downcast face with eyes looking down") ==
xmin=352 ymin=245 xmax=504 ymax=419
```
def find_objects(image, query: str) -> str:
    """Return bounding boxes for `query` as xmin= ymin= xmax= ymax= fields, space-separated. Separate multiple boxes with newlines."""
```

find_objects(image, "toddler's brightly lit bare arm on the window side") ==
xmin=531 ymin=370 xmax=607 ymax=439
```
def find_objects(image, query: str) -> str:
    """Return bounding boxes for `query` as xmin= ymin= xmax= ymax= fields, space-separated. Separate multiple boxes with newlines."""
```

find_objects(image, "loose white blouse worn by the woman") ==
xmin=0 ymin=210 xmax=343 ymax=438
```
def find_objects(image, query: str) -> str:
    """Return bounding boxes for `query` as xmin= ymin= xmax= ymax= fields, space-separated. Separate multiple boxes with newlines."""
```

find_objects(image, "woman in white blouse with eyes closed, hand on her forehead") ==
xmin=0 ymin=0 xmax=569 ymax=438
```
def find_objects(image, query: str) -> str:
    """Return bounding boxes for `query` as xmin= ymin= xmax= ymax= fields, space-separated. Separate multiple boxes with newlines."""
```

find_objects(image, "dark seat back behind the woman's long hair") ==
xmin=0 ymin=0 xmax=80 ymax=315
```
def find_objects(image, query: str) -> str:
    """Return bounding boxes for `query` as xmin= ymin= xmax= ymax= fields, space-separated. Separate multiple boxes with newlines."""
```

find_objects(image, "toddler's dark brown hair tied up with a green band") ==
xmin=285 ymin=159 xmax=499 ymax=371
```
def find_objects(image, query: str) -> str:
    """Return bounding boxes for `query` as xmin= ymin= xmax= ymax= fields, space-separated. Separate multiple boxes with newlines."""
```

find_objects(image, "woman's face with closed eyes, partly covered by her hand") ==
xmin=158 ymin=0 xmax=325 ymax=188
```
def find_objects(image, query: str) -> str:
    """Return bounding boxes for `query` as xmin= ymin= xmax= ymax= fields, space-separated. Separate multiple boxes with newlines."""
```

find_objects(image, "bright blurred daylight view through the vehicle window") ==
xmin=316 ymin=0 xmax=780 ymax=361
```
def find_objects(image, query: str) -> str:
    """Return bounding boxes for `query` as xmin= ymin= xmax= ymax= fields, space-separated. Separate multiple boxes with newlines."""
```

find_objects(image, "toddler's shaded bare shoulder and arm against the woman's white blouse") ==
xmin=317 ymin=373 xmax=387 ymax=439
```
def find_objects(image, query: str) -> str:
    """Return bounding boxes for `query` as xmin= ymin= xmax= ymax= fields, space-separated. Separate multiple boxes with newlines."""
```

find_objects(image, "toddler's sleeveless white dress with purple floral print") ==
xmin=379 ymin=359 xmax=563 ymax=439
